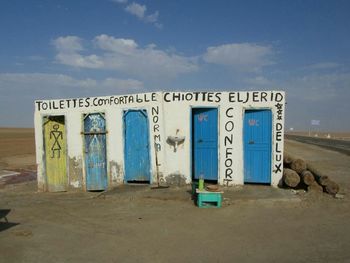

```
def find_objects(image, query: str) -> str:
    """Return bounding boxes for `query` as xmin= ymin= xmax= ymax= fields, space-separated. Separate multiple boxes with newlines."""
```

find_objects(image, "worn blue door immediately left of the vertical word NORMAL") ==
xmin=124 ymin=110 xmax=151 ymax=183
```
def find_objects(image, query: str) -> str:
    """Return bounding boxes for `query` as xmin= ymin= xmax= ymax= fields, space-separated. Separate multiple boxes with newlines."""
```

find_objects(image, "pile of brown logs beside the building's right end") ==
xmin=282 ymin=153 xmax=339 ymax=196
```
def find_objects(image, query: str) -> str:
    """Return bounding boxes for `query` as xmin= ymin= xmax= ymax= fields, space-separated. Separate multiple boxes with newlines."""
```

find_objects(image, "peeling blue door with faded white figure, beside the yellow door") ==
xmin=84 ymin=113 xmax=107 ymax=190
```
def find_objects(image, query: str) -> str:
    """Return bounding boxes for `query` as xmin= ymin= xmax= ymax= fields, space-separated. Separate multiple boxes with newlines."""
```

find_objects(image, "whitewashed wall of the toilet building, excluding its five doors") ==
xmin=34 ymin=91 xmax=285 ymax=191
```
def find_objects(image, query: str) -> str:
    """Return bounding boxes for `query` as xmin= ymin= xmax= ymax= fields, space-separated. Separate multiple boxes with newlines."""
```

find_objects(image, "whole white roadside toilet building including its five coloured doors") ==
xmin=34 ymin=91 xmax=285 ymax=192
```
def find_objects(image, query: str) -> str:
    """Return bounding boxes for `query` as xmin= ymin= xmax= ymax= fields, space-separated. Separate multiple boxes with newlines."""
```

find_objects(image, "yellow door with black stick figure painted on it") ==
xmin=43 ymin=116 xmax=68 ymax=192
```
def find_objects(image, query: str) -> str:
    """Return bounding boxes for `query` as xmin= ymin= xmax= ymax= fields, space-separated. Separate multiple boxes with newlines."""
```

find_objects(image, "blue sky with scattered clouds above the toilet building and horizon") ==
xmin=0 ymin=0 xmax=350 ymax=131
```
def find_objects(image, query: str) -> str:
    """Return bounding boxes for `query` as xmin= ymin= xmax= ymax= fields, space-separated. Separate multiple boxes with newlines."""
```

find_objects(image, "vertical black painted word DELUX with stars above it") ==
xmin=274 ymin=96 xmax=283 ymax=173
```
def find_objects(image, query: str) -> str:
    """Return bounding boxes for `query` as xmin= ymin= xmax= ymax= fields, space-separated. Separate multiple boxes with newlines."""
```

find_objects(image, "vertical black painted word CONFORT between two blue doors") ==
xmin=224 ymin=108 xmax=235 ymax=185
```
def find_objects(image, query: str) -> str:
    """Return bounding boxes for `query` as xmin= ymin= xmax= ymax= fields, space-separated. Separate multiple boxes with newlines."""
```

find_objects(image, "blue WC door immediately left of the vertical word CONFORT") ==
xmin=192 ymin=108 xmax=218 ymax=180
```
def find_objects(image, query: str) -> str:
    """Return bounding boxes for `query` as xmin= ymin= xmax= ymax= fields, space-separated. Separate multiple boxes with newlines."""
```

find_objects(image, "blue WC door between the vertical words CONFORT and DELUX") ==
xmin=244 ymin=110 xmax=272 ymax=184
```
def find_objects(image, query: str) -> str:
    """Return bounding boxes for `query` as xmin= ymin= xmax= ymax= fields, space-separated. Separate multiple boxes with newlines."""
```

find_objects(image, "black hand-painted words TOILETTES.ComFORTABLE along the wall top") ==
xmin=35 ymin=93 xmax=157 ymax=111
